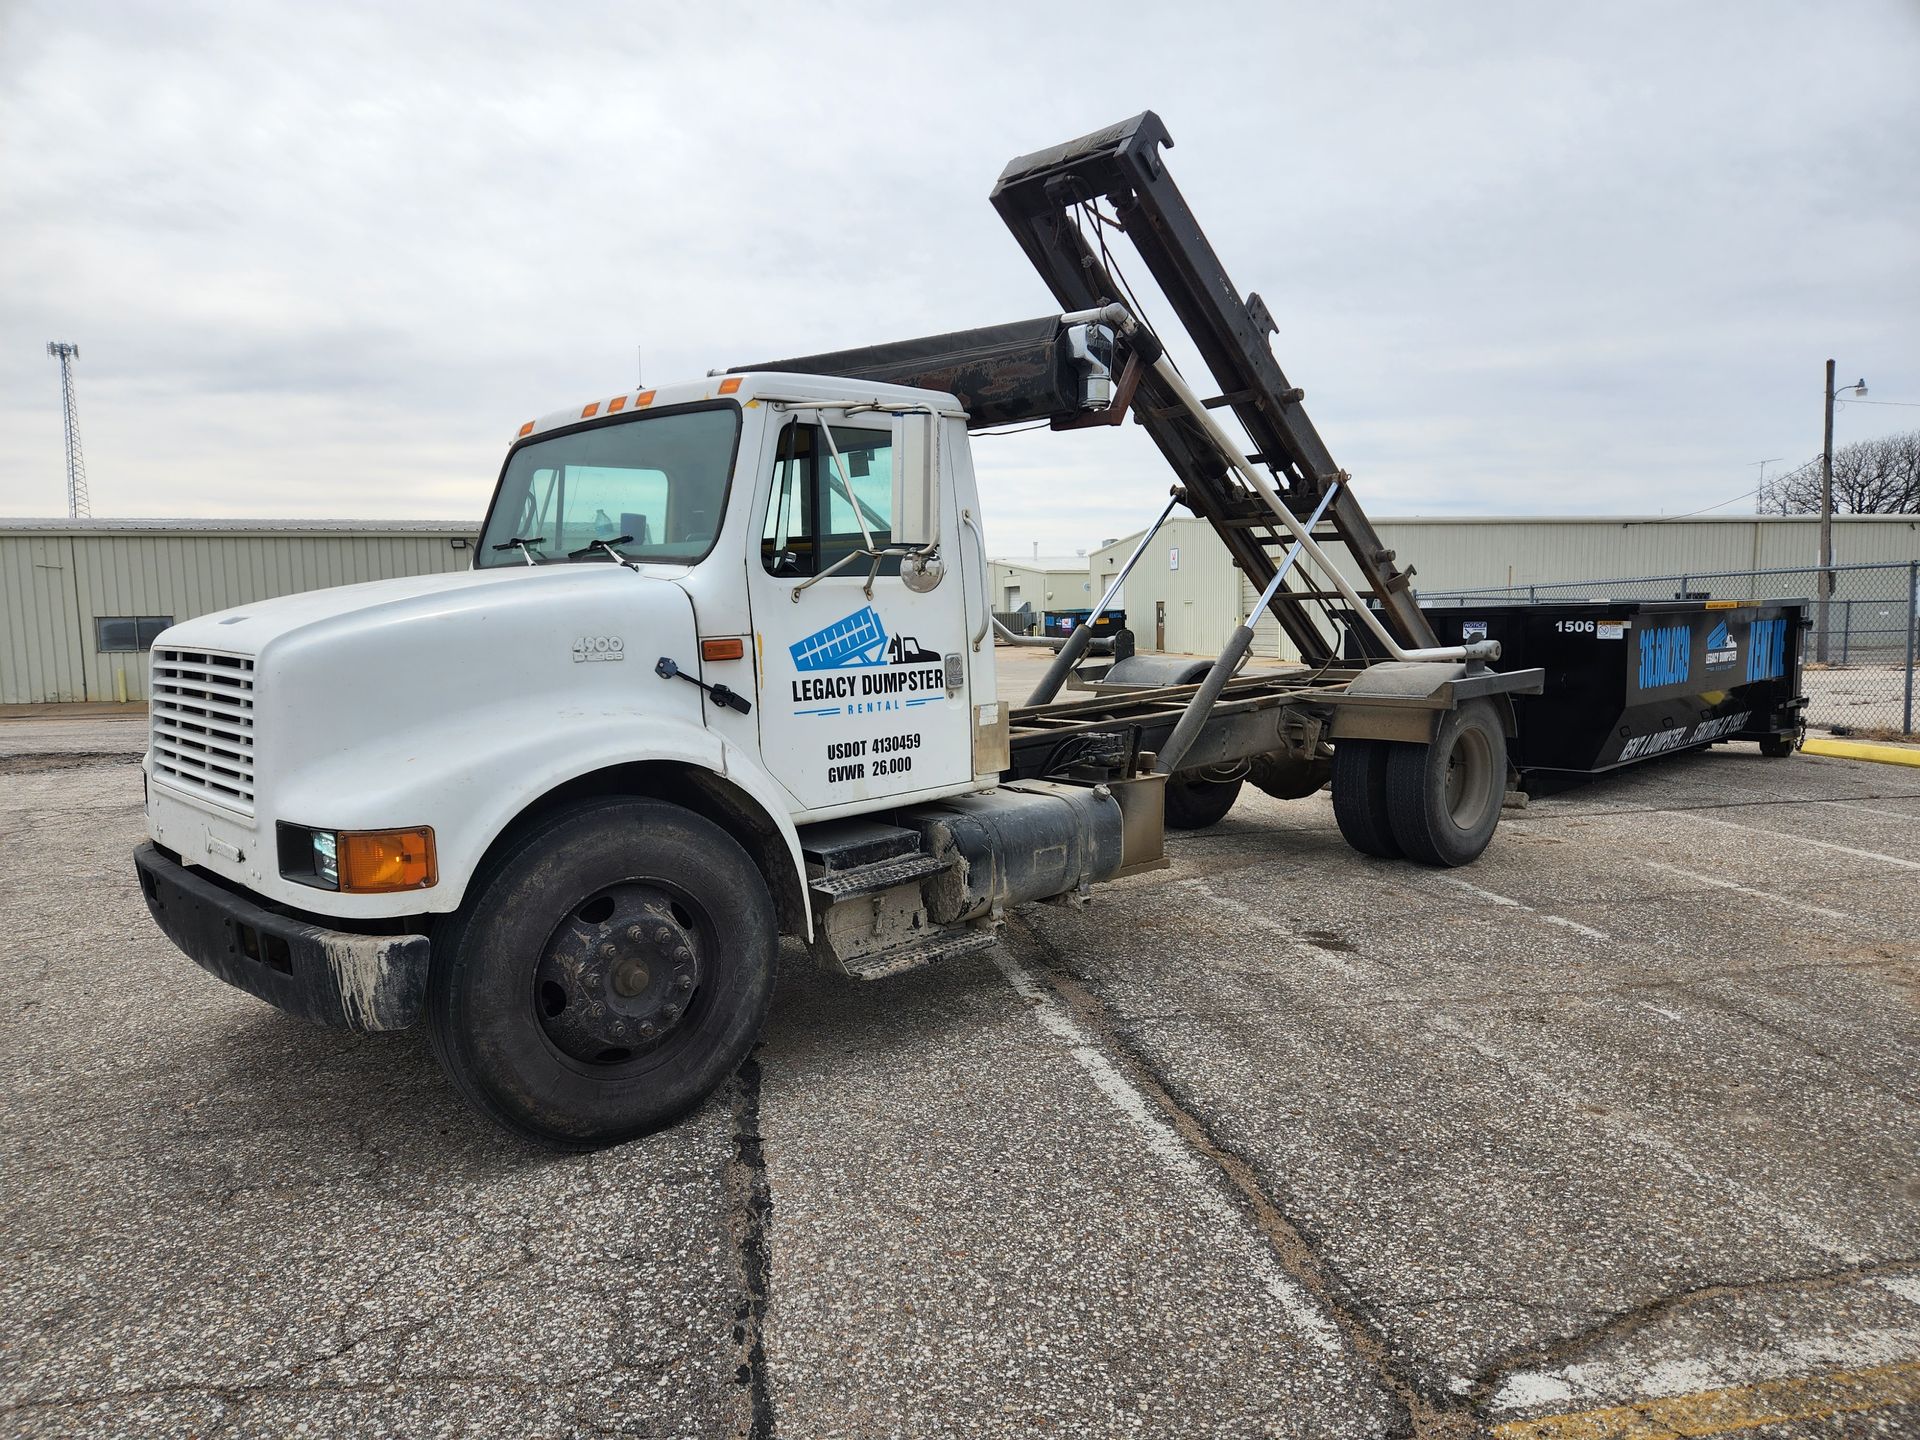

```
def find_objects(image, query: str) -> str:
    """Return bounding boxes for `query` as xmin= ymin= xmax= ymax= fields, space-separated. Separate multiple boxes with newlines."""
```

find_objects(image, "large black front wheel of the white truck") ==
xmin=426 ymin=797 xmax=780 ymax=1150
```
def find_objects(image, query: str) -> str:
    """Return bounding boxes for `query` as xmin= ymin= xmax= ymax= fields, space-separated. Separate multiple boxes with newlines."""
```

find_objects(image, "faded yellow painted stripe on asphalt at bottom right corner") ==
xmin=1492 ymin=1361 xmax=1920 ymax=1440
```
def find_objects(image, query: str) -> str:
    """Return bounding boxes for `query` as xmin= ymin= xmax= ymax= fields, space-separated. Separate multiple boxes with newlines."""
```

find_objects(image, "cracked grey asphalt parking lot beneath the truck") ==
xmin=11 ymin=683 xmax=1920 ymax=1440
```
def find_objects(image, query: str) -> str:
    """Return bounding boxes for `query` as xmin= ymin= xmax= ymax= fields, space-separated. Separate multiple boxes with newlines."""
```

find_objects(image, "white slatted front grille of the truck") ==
xmin=146 ymin=649 xmax=253 ymax=814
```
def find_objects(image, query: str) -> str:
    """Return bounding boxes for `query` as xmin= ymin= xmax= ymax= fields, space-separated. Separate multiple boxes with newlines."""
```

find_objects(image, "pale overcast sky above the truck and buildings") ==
xmin=0 ymin=0 xmax=1920 ymax=553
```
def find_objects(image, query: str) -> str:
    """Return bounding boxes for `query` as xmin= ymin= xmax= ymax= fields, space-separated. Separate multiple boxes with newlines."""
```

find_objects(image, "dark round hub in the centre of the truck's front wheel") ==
xmin=534 ymin=885 xmax=701 ymax=1064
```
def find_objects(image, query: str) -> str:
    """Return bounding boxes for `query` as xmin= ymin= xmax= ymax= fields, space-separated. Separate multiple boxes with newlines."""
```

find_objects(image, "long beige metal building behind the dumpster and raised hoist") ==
xmin=1091 ymin=515 xmax=1920 ymax=659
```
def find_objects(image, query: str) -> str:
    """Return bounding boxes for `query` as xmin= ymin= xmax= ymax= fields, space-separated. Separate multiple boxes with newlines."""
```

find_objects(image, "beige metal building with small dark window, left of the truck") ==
xmin=0 ymin=520 xmax=480 ymax=705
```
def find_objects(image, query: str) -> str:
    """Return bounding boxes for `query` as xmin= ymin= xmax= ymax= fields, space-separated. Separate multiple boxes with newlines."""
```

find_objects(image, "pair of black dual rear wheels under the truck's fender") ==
xmin=1332 ymin=699 xmax=1507 ymax=866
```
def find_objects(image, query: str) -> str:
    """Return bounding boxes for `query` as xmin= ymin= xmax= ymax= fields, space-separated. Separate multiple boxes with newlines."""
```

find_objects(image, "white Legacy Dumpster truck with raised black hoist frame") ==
xmin=136 ymin=113 xmax=1540 ymax=1146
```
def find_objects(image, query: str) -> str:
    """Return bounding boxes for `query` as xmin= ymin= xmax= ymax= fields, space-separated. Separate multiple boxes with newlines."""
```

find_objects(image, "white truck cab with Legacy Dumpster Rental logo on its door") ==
xmin=476 ymin=374 xmax=1000 ymax=824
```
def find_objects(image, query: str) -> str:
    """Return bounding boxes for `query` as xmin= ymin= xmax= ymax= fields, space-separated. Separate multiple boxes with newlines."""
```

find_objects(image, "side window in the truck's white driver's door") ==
xmin=760 ymin=420 xmax=900 ymax=578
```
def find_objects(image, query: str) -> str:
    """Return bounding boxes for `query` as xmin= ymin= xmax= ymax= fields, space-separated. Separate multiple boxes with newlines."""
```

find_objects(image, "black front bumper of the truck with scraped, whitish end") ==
xmin=132 ymin=845 xmax=430 ymax=1029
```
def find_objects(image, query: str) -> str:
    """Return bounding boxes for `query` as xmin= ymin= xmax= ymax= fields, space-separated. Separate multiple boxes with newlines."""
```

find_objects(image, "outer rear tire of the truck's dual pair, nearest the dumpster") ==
xmin=1386 ymin=699 xmax=1507 ymax=866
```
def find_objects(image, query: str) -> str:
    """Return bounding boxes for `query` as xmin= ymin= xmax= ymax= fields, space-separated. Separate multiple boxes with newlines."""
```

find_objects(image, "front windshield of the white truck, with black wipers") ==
xmin=476 ymin=405 xmax=739 ymax=566
